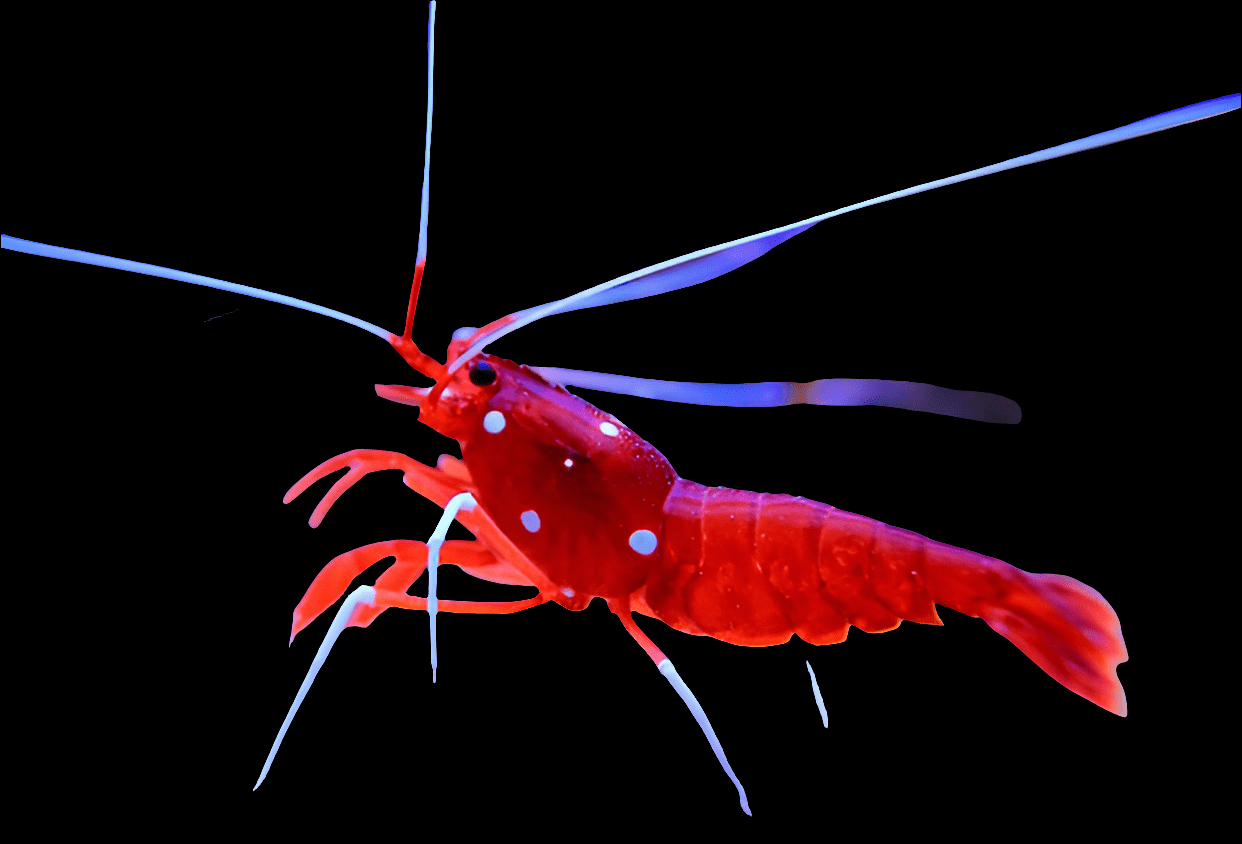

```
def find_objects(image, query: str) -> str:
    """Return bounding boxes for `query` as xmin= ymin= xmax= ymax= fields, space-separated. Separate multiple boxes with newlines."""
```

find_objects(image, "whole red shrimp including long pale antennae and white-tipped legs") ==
xmin=4 ymin=4 xmax=1240 ymax=813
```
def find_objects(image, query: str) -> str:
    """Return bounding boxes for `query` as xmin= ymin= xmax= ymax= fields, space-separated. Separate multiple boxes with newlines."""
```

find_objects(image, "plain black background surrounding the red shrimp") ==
xmin=4 ymin=4 xmax=1237 ymax=835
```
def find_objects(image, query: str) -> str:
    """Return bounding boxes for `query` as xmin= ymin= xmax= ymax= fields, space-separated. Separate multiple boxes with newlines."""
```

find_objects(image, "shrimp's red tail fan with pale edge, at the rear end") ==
xmin=923 ymin=544 xmax=1129 ymax=716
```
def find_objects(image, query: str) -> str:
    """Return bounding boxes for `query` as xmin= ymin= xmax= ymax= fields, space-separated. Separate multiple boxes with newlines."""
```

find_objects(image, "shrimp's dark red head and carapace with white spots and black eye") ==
xmin=387 ymin=322 xmax=677 ymax=593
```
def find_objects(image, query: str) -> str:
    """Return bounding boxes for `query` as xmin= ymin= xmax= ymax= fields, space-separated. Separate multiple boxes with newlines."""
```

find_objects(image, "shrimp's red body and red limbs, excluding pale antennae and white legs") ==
xmin=308 ymin=350 xmax=1126 ymax=715
